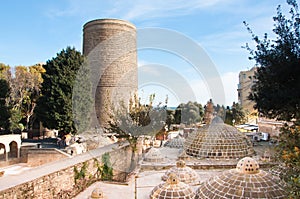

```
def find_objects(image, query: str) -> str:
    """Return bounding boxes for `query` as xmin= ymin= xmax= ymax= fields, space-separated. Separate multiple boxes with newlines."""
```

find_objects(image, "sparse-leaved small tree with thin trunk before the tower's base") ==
xmin=105 ymin=94 xmax=167 ymax=172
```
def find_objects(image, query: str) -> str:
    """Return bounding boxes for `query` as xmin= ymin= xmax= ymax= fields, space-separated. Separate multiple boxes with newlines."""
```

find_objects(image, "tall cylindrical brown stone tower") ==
xmin=83 ymin=19 xmax=138 ymax=127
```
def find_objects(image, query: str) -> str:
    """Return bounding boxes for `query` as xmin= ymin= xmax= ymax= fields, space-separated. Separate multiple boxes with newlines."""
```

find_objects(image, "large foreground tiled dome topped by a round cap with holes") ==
xmin=195 ymin=157 xmax=286 ymax=199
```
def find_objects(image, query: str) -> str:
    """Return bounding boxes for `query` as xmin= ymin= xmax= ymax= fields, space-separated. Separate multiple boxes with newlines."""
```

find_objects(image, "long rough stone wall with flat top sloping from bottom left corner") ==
xmin=0 ymin=144 xmax=141 ymax=199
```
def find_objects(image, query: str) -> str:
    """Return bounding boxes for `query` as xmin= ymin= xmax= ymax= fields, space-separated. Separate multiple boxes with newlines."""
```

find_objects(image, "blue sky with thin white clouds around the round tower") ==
xmin=0 ymin=0 xmax=288 ymax=106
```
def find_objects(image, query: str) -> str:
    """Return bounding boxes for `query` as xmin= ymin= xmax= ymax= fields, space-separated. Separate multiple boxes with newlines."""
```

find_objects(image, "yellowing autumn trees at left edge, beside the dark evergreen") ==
xmin=0 ymin=64 xmax=44 ymax=131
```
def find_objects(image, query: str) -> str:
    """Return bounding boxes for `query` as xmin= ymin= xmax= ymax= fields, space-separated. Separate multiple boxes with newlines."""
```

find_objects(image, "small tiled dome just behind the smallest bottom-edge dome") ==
xmin=161 ymin=160 xmax=199 ymax=185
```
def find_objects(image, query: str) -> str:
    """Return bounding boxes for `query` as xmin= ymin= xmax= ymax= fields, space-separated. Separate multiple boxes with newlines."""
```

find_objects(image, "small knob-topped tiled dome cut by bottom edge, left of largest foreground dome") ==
xmin=150 ymin=173 xmax=195 ymax=199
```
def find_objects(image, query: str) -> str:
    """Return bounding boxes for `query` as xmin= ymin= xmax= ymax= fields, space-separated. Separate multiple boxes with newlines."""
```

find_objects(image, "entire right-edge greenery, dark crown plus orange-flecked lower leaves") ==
xmin=245 ymin=0 xmax=300 ymax=198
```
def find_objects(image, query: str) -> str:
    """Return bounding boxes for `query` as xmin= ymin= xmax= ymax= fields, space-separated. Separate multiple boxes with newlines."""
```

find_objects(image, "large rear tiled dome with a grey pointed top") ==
xmin=184 ymin=117 xmax=254 ymax=159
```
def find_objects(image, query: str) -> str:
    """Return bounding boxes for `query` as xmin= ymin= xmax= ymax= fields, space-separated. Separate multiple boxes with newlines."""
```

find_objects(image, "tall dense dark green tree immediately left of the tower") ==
xmin=36 ymin=47 xmax=84 ymax=134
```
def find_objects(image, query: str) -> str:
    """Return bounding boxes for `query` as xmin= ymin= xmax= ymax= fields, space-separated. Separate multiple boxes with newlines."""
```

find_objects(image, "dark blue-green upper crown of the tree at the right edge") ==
xmin=245 ymin=0 xmax=300 ymax=120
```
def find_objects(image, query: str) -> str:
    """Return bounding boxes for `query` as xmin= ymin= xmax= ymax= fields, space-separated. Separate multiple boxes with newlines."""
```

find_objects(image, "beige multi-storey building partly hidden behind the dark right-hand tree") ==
xmin=237 ymin=67 xmax=257 ymax=123
